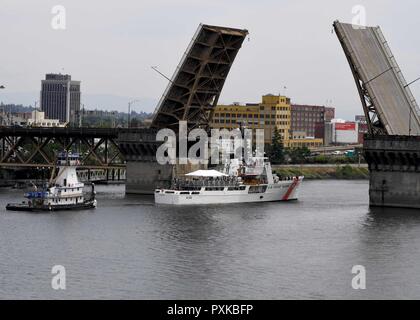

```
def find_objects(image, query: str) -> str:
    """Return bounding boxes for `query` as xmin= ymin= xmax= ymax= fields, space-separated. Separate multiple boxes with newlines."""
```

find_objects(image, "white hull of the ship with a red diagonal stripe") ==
xmin=155 ymin=177 xmax=303 ymax=205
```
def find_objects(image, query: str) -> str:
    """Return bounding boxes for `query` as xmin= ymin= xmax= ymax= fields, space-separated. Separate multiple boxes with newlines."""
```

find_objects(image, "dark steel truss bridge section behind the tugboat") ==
xmin=0 ymin=127 xmax=141 ymax=169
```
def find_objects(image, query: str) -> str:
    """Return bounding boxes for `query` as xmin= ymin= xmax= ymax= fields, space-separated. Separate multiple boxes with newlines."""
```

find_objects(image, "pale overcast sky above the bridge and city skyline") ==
xmin=0 ymin=0 xmax=420 ymax=120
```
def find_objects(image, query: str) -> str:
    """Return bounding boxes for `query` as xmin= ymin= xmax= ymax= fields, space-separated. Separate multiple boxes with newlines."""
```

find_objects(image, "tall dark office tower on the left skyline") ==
xmin=41 ymin=73 xmax=80 ymax=126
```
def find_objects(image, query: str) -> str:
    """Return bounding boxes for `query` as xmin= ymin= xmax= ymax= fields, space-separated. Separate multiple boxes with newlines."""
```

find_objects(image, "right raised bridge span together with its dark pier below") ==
xmin=334 ymin=21 xmax=420 ymax=208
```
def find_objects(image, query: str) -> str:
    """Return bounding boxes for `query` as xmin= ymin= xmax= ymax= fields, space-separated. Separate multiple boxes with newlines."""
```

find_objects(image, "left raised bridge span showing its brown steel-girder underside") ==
xmin=152 ymin=24 xmax=248 ymax=130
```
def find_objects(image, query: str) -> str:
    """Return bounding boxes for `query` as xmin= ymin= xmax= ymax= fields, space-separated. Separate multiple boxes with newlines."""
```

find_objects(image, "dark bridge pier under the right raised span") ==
xmin=364 ymin=136 xmax=420 ymax=208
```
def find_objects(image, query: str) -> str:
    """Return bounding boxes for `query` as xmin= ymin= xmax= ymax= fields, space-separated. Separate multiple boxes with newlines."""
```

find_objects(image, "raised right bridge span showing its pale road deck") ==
xmin=334 ymin=21 xmax=420 ymax=135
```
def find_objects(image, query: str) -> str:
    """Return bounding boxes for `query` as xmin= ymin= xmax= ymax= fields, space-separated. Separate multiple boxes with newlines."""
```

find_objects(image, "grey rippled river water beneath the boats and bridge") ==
xmin=0 ymin=180 xmax=420 ymax=299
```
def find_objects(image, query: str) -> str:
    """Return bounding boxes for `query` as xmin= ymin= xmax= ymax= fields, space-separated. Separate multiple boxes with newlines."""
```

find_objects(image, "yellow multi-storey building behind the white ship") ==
xmin=211 ymin=94 xmax=323 ymax=147
